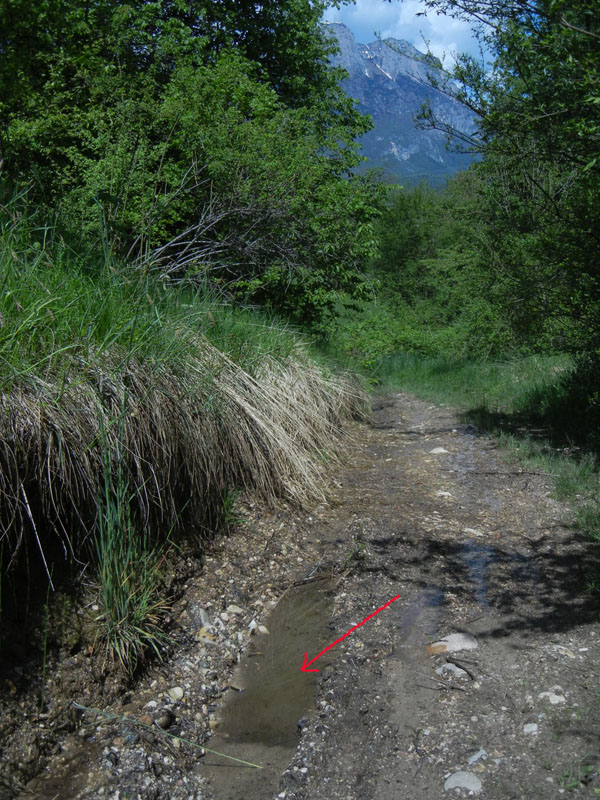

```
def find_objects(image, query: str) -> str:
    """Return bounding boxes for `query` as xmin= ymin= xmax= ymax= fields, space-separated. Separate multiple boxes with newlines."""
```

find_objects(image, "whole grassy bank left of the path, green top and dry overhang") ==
xmin=0 ymin=189 xmax=363 ymax=669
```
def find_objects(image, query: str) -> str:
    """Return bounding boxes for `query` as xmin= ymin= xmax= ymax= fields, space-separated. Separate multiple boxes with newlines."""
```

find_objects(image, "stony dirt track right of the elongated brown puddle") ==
xmin=278 ymin=395 xmax=600 ymax=800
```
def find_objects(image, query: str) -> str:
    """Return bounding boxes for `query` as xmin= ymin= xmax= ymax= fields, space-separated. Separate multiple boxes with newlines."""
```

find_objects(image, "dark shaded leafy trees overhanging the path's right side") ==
xmin=418 ymin=0 xmax=600 ymax=360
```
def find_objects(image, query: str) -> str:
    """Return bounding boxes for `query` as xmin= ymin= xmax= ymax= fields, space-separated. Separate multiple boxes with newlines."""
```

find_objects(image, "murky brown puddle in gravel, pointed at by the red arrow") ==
xmin=202 ymin=580 xmax=335 ymax=800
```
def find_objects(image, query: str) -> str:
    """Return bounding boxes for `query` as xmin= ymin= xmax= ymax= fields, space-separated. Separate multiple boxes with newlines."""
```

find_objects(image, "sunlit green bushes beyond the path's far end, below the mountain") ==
xmin=337 ymin=171 xmax=524 ymax=373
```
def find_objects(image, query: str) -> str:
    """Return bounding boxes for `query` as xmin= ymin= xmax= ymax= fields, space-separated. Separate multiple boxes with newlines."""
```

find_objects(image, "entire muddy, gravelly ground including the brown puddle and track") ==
xmin=0 ymin=394 xmax=600 ymax=800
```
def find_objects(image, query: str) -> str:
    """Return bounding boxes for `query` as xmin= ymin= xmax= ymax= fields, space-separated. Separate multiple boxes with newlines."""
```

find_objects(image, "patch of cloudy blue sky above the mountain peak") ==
xmin=325 ymin=0 xmax=478 ymax=67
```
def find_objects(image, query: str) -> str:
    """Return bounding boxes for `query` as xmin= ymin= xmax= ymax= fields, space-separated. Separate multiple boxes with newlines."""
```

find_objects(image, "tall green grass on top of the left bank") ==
xmin=0 ymin=198 xmax=297 ymax=389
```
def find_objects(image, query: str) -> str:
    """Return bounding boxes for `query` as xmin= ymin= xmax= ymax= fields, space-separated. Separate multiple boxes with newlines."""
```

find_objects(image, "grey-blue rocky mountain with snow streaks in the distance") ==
xmin=328 ymin=23 xmax=473 ymax=184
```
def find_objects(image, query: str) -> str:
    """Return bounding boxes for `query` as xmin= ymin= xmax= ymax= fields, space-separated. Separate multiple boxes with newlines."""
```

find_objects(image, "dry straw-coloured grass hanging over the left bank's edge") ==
xmin=0 ymin=331 xmax=364 ymax=574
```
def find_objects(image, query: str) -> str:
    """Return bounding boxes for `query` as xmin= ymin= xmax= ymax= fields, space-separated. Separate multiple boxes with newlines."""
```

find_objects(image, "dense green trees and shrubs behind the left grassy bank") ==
xmin=0 ymin=0 xmax=376 ymax=322
